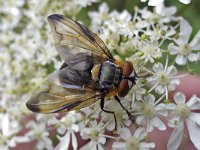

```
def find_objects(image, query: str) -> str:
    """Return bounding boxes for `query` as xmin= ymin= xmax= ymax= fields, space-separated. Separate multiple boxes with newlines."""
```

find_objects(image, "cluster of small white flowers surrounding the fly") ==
xmin=0 ymin=0 xmax=200 ymax=150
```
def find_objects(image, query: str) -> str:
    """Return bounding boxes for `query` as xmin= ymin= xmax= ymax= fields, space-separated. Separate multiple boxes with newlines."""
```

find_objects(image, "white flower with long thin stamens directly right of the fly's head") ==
xmin=147 ymin=60 xmax=180 ymax=95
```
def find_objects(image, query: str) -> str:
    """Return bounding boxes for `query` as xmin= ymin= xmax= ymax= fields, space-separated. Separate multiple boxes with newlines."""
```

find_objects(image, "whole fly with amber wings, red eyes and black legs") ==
xmin=26 ymin=14 xmax=137 ymax=128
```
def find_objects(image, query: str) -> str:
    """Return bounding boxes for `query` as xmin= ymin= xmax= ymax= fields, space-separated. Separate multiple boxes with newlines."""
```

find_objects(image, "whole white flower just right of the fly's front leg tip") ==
xmin=134 ymin=94 xmax=167 ymax=132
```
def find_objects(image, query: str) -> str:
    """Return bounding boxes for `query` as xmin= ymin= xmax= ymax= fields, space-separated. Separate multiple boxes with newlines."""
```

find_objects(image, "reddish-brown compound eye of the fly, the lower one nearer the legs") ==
xmin=118 ymin=79 xmax=129 ymax=97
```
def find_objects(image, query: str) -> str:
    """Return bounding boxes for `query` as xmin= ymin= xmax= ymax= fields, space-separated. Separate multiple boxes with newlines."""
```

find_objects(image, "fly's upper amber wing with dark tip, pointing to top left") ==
xmin=48 ymin=14 xmax=114 ymax=70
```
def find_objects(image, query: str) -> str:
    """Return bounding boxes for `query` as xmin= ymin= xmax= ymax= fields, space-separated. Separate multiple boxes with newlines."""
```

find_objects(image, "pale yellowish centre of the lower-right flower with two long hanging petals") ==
xmin=176 ymin=104 xmax=190 ymax=119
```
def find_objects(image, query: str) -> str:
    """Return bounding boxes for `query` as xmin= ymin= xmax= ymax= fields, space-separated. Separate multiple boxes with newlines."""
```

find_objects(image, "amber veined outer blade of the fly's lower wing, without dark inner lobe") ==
xmin=26 ymin=83 xmax=102 ymax=113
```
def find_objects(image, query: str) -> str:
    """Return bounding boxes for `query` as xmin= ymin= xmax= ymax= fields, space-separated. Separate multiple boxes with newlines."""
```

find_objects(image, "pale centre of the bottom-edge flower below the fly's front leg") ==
xmin=126 ymin=136 xmax=139 ymax=150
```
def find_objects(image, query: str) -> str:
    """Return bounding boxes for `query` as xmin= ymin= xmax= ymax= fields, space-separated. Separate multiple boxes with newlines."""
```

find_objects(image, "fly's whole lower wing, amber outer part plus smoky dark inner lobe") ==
xmin=26 ymin=63 xmax=103 ymax=113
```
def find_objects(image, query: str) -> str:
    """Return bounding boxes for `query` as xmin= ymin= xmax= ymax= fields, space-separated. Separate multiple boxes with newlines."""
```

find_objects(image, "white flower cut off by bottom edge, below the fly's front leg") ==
xmin=112 ymin=128 xmax=155 ymax=150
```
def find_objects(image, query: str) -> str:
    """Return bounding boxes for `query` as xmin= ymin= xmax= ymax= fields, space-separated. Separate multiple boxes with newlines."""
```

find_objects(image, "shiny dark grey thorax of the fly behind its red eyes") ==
xmin=99 ymin=61 xmax=121 ymax=89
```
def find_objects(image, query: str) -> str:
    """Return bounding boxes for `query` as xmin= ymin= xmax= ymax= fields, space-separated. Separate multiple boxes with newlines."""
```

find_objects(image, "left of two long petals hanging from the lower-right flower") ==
xmin=167 ymin=122 xmax=184 ymax=150
